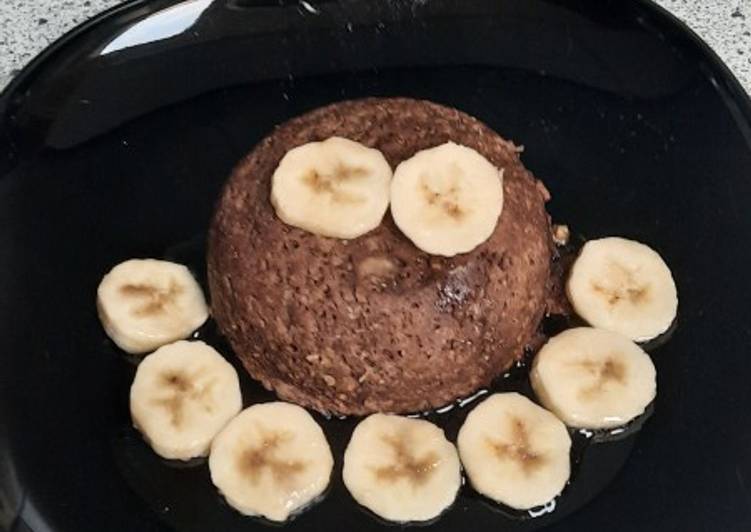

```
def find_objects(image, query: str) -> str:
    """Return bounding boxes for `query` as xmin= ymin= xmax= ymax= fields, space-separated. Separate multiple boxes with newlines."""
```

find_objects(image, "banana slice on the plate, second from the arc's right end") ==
xmin=530 ymin=327 xmax=657 ymax=429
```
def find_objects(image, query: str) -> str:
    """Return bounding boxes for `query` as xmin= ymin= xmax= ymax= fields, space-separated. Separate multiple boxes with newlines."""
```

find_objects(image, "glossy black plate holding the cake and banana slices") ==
xmin=0 ymin=0 xmax=751 ymax=531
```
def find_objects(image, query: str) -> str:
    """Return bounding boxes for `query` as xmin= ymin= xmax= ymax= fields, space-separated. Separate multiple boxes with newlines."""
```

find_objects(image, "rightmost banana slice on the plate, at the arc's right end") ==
xmin=566 ymin=237 xmax=678 ymax=342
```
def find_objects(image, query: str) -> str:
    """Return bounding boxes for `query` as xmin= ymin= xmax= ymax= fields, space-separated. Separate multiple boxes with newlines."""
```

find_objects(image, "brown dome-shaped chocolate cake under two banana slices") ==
xmin=208 ymin=98 xmax=557 ymax=414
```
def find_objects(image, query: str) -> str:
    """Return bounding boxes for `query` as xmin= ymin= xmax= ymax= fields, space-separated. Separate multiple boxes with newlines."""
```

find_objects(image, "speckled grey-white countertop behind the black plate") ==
xmin=0 ymin=0 xmax=751 ymax=93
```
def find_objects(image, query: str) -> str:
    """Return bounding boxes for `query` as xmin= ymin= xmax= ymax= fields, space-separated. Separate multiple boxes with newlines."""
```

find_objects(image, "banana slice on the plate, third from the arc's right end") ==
xmin=457 ymin=393 xmax=571 ymax=510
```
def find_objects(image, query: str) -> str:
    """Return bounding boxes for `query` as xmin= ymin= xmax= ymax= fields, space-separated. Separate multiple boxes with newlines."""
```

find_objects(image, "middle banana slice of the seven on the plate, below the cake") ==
xmin=342 ymin=414 xmax=461 ymax=522
